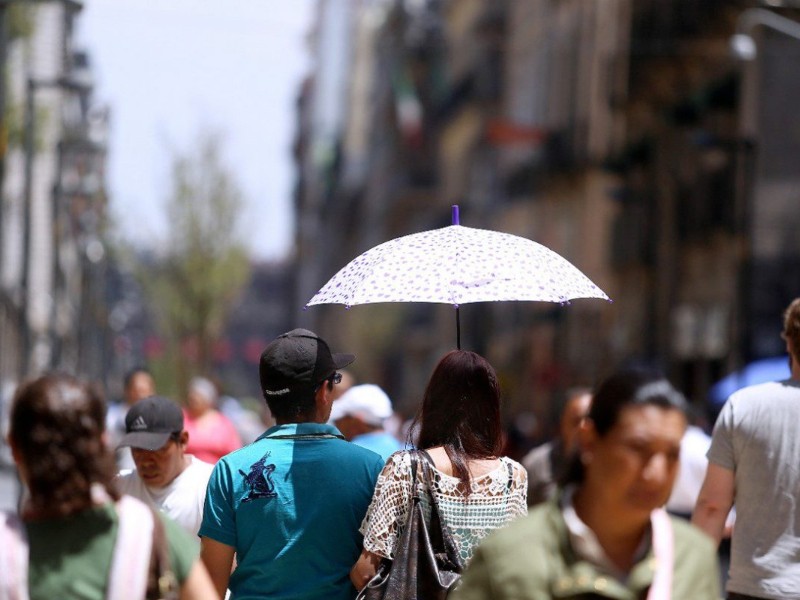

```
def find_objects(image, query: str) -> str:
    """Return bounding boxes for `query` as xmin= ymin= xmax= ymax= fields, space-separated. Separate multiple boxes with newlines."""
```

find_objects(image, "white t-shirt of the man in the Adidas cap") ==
xmin=116 ymin=454 xmax=214 ymax=535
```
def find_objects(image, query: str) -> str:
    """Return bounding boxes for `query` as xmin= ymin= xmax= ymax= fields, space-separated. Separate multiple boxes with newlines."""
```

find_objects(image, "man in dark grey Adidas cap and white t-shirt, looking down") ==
xmin=116 ymin=396 xmax=214 ymax=535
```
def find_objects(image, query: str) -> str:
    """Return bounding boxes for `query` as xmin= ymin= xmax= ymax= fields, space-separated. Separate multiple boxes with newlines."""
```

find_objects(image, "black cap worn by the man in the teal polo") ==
xmin=258 ymin=329 xmax=356 ymax=398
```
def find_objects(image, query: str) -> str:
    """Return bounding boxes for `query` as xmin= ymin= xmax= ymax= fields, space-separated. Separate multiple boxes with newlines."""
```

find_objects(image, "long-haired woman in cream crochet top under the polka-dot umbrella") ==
xmin=350 ymin=350 xmax=527 ymax=590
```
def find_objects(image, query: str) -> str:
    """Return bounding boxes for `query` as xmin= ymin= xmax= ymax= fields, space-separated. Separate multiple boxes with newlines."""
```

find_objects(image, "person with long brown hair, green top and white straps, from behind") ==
xmin=0 ymin=375 xmax=217 ymax=600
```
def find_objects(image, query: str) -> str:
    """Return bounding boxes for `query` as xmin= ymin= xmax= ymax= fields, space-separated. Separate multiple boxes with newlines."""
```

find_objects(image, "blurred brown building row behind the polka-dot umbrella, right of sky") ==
xmin=294 ymin=0 xmax=800 ymax=436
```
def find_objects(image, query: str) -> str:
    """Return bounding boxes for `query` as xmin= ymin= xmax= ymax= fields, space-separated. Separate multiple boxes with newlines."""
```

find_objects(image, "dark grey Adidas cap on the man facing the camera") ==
xmin=117 ymin=396 xmax=183 ymax=450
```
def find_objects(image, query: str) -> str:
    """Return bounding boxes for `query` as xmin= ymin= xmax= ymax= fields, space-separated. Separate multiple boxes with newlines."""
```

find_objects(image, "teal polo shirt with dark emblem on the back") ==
xmin=199 ymin=423 xmax=384 ymax=600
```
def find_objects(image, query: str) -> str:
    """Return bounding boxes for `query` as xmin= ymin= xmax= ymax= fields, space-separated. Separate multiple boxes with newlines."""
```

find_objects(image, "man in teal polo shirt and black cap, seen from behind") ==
xmin=199 ymin=329 xmax=383 ymax=600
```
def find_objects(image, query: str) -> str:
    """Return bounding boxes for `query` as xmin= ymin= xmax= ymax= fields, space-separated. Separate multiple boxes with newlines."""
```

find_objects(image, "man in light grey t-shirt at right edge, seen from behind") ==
xmin=692 ymin=298 xmax=800 ymax=600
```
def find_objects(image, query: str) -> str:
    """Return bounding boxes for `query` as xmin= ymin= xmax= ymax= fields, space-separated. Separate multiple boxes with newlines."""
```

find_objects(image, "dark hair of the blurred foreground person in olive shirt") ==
xmin=559 ymin=368 xmax=688 ymax=486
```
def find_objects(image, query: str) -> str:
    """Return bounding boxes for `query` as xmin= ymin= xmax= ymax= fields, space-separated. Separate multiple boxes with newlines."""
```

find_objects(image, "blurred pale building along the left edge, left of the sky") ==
xmin=0 ymin=0 xmax=110 ymax=394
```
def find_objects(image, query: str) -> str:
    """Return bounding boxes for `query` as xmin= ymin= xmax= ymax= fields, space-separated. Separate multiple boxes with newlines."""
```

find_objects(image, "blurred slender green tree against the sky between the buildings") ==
xmin=140 ymin=133 xmax=250 ymax=392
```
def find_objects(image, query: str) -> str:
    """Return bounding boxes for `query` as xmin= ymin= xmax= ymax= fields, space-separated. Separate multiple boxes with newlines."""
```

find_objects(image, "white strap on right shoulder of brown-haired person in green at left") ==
xmin=106 ymin=496 xmax=153 ymax=600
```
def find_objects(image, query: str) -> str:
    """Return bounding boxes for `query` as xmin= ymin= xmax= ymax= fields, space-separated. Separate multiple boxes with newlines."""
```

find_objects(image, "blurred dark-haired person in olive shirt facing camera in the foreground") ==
xmin=453 ymin=370 xmax=719 ymax=600
